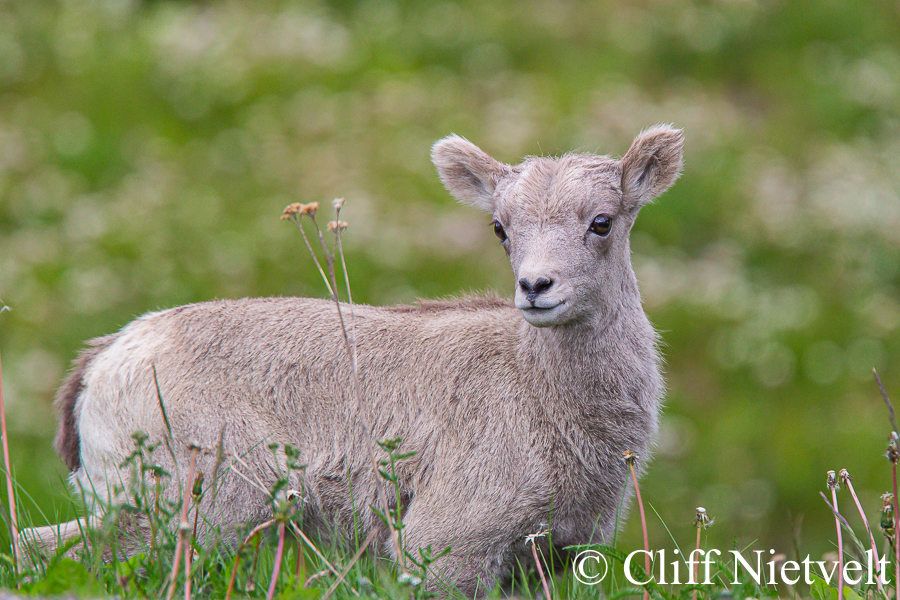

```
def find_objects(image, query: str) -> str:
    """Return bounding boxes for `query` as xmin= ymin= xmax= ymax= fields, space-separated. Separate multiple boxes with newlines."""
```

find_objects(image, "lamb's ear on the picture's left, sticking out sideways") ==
xmin=431 ymin=135 xmax=509 ymax=212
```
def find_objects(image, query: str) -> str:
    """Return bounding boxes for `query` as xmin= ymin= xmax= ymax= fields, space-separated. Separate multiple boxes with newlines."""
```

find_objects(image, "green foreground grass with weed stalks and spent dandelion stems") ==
xmin=0 ymin=200 xmax=900 ymax=600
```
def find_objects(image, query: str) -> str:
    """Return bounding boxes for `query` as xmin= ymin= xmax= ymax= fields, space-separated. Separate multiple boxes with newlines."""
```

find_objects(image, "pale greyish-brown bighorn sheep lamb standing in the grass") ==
xmin=23 ymin=125 xmax=683 ymax=596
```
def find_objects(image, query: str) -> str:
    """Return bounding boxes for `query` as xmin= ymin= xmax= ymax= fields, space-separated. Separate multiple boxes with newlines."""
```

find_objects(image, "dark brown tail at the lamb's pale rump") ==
xmin=53 ymin=335 xmax=116 ymax=471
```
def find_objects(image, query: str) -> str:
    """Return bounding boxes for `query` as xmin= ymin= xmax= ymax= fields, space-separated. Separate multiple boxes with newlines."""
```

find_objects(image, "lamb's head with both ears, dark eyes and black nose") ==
xmin=432 ymin=125 xmax=684 ymax=327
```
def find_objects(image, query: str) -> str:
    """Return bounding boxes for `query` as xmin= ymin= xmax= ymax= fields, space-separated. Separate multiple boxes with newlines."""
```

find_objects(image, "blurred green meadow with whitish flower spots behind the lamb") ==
xmin=0 ymin=0 xmax=900 ymax=556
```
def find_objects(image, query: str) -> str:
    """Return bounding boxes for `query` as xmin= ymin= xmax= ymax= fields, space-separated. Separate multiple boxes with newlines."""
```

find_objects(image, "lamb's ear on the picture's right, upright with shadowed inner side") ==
xmin=620 ymin=125 xmax=684 ymax=210
